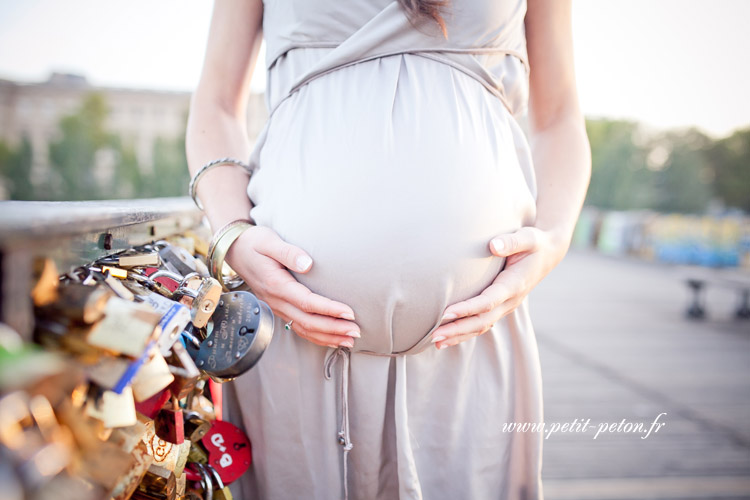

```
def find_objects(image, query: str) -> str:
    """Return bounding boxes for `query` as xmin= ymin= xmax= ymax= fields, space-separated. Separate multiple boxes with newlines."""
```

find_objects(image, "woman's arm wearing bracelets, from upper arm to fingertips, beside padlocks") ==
xmin=185 ymin=0 xmax=359 ymax=347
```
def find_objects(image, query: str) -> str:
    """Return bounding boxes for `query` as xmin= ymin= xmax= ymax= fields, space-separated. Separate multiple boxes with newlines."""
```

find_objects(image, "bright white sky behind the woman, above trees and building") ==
xmin=0 ymin=0 xmax=750 ymax=137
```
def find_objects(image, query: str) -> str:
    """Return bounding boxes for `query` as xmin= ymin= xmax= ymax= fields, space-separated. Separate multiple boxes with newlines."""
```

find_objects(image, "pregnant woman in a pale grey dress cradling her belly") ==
xmin=187 ymin=0 xmax=590 ymax=500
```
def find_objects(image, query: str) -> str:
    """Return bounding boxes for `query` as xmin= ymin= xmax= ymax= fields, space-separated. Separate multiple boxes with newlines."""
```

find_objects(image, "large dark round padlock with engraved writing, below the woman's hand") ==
xmin=187 ymin=292 xmax=274 ymax=380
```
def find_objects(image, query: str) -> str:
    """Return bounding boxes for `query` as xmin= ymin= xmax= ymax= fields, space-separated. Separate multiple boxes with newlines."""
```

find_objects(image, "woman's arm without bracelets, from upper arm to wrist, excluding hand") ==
xmin=526 ymin=0 xmax=591 ymax=249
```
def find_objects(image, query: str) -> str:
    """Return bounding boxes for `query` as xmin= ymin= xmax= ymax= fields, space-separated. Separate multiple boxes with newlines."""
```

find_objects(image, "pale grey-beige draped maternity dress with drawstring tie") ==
xmin=224 ymin=0 xmax=543 ymax=500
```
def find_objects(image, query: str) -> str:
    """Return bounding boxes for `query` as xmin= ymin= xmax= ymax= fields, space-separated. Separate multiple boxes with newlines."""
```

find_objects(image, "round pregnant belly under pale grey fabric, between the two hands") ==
xmin=248 ymin=56 xmax=534 ymax=353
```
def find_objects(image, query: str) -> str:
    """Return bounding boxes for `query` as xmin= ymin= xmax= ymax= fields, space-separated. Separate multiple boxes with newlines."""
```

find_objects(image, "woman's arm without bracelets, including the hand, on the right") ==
xmin=432 ymin=0 xmax=591 ymax=349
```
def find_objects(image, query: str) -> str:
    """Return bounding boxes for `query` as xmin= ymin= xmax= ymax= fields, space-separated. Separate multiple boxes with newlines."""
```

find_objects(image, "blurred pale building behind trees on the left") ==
xmin=0 ymin=73 xmax=268 ymax=183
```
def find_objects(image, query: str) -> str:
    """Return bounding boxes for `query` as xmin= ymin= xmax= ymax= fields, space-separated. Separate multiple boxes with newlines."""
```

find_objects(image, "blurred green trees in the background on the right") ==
xmin=586 ymin=119 xmax=750 ymax=213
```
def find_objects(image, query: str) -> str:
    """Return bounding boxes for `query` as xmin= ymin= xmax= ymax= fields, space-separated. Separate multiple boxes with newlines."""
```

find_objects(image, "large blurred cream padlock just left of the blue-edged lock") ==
xmin=87 ymin=297 xmax=161 ymax=357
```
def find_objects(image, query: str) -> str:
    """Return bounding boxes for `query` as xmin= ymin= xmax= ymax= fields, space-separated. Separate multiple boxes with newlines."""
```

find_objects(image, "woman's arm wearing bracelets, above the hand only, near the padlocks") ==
xmin=185 ymin=0 xmax=263 ymax=230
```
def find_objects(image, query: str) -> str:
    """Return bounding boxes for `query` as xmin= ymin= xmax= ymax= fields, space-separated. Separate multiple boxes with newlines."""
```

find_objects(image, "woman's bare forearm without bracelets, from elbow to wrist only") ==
xmin=530 ymin=112 xmax=591 ymax=254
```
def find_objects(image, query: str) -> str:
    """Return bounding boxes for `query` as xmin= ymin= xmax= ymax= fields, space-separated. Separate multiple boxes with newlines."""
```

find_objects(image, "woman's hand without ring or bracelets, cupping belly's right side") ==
xmin=432 ymin=226 xmax=569 ymax=349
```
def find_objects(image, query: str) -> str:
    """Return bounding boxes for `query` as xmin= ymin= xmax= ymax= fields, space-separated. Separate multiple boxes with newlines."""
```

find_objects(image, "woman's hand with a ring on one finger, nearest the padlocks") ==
xmin=226 ymin=226 xmax=360 ymax=347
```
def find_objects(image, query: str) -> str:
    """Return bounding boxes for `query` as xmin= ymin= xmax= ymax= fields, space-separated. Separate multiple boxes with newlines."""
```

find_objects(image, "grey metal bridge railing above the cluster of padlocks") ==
xmin=0 ymin=197 xmax=203 ymax=340
